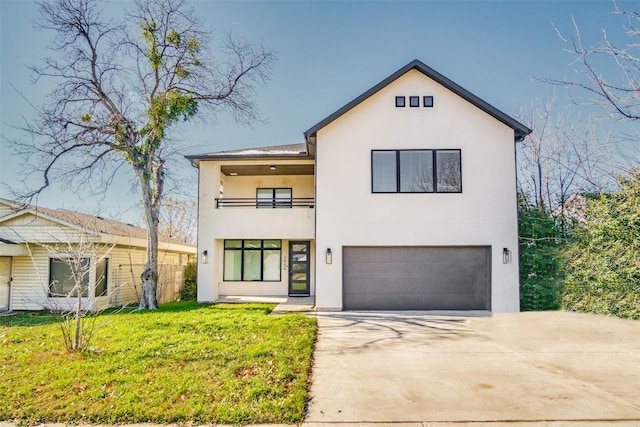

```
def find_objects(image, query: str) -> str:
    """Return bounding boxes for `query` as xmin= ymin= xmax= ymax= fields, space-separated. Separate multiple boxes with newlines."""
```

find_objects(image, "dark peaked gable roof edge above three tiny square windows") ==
xmin=304 ymin=59 xmax=531 ymax=142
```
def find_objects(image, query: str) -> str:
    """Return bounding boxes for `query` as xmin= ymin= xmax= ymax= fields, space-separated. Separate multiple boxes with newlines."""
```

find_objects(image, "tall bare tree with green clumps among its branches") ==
xmin=16 ymin=0 xmax=275 ymax=309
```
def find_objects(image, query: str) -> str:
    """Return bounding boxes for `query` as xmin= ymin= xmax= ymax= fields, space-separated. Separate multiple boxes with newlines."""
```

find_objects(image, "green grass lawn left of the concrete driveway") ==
xmin=0 ymin=302 xmax=316 ymax=424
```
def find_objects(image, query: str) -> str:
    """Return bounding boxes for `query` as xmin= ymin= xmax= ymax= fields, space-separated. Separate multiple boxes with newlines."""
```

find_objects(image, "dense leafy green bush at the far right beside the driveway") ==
xmin=562 ymin=172 xmax=640 ymax=319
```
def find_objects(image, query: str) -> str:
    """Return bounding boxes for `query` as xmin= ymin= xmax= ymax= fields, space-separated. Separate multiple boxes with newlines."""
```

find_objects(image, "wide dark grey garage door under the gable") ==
xmin=342 ymin=246 xmax=491 ymax=310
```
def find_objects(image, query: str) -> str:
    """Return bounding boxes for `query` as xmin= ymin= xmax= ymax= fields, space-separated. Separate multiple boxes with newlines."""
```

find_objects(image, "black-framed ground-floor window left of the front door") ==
xmin=223 ymin=239 xmax=282 ymax=282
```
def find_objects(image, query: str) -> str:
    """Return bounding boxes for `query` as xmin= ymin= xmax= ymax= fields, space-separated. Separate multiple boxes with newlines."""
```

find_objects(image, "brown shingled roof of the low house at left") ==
xmin=0 ymin=199 xmax=193 ymax=247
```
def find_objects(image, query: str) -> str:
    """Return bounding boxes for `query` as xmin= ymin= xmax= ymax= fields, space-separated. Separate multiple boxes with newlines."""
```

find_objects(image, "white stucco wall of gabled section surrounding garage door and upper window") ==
xmin=316 ymin=70 xmax=519 ymax=312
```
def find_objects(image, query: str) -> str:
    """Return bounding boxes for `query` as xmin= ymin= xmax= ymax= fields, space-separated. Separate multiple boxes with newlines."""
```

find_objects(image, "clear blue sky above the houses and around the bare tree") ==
xmin=0 ymin=0 xmax=637 ymax=223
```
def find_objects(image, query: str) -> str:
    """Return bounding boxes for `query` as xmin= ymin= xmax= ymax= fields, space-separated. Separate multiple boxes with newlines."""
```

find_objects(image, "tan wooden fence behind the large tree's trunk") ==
xmin=113 ymin=264 xmax=184 ymax=307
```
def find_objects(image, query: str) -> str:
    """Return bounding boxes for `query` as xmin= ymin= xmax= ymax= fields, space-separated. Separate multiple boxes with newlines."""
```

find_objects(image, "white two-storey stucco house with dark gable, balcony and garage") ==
xmin=187 ymin=60 xmax=531 ymax=312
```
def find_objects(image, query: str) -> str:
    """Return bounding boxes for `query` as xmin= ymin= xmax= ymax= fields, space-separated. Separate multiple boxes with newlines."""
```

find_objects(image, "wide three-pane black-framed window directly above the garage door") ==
xmin=371 ymin=149 xmax=462 ymax=193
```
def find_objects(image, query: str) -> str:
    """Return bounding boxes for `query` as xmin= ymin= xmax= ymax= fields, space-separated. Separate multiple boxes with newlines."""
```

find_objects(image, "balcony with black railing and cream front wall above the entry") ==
xmin=210 ymin=198 xmax=315 ymax=240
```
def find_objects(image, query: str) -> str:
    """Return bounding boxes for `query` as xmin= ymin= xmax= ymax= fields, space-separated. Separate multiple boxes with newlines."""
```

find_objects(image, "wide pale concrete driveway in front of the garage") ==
xmin=305 ymin=312 xmax=640 ymax=426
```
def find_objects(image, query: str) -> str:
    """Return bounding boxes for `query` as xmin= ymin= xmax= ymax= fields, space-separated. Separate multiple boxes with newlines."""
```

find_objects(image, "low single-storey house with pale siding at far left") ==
xmin=0 ymin=199 xmax=196 ymax=311
